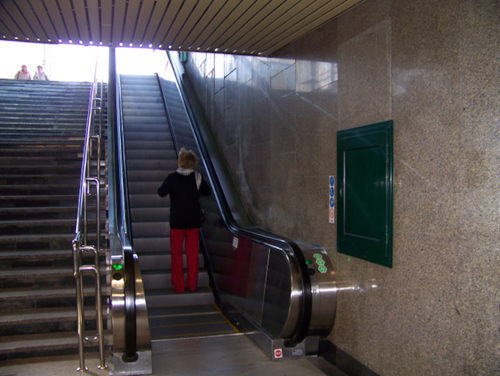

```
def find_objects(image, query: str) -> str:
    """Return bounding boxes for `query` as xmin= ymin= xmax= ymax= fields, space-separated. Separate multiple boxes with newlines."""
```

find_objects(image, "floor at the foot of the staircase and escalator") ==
xmin=0 ymin=335 xmax=333 ymax=376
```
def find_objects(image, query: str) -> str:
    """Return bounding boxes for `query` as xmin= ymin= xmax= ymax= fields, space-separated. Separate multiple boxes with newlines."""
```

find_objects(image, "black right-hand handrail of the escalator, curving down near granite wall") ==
xmin=167 ymin=52 xmax=312 ymax=346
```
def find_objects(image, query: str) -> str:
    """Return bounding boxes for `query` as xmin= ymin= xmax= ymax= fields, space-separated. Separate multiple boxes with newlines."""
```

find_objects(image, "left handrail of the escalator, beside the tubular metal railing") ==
xmin=115 ymin=75 xmax=137 ymax=361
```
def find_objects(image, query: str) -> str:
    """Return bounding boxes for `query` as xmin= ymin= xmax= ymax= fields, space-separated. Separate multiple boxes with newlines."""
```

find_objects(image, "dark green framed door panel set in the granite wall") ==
xmin=337 ymin=121 xmax=393 ymax=267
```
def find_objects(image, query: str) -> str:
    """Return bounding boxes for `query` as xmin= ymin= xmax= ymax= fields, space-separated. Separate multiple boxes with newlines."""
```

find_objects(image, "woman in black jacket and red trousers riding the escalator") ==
xmin=158 ymin=148 xmax=211 ymax=292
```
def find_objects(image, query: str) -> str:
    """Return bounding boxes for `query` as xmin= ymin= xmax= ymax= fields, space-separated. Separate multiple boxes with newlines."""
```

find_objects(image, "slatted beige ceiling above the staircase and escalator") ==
xmin=0 ymin=0 xmax=362 ymax=56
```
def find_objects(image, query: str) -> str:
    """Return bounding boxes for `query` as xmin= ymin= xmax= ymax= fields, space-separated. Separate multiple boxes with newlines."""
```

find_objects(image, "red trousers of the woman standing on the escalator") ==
xmin=170 ymin=228 xmax=200 ymax=292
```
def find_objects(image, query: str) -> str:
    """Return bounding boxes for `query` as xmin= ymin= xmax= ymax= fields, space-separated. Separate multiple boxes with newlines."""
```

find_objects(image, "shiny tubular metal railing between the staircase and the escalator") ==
xmin=72 ymin=62 xmax=107 ymax=371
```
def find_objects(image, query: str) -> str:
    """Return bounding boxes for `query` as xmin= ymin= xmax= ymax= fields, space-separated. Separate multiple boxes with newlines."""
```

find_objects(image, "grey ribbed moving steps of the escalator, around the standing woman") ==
xmin=121 ymin=75 xmax=235 ymax=340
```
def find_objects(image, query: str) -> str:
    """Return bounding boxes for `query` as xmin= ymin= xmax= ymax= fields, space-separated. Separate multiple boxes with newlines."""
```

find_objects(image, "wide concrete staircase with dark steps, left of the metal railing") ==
xmin=0 ymin=80 xmax=109 ymax=360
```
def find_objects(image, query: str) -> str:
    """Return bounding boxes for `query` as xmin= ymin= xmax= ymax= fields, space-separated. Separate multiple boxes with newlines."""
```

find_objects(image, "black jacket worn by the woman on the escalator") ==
xmin=158 ymin=172 xmax=211 ymax=229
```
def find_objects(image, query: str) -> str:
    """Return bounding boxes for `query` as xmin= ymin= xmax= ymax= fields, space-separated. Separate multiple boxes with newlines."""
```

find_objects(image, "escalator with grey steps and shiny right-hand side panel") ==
xmin=109 ymin=50 xmax=336 ymax=370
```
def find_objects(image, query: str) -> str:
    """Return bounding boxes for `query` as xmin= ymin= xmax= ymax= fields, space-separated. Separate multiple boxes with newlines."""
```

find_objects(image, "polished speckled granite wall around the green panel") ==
xmin=183 ymin=0 xmax=500 ymax=376
